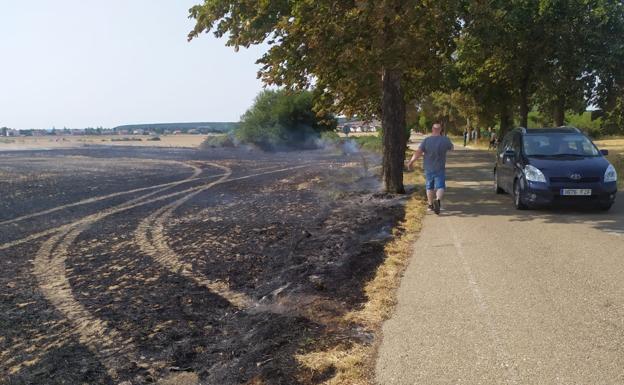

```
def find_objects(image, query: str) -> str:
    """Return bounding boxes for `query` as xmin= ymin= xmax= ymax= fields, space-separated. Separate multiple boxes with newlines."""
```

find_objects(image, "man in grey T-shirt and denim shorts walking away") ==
xmin=407 ymin=123 xmax=453 ymax=214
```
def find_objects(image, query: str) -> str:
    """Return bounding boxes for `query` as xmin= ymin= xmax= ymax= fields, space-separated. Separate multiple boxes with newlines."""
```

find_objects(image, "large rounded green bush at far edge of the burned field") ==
xmin=234 ymin=90 xmax=336 ymax=150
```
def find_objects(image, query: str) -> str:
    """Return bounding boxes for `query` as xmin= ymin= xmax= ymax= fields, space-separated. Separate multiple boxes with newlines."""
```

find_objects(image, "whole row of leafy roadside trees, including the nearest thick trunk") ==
xmin=189 ymin=0 xmax=624 ymax=192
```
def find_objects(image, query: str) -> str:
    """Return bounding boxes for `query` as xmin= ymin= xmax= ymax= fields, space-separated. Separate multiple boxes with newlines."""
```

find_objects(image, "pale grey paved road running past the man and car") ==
xmin=376 ymin=146 xmax=624 ymax=385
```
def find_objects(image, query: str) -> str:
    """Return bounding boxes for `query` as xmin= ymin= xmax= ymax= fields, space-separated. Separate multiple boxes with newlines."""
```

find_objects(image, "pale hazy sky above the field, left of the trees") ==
xmin=0 ymin=0 xmax=265 ymax=129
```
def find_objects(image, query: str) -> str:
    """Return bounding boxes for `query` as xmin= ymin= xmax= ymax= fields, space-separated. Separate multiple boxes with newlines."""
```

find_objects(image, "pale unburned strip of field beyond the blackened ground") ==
xmin=0 ymin=135 xmax=208 ymax=151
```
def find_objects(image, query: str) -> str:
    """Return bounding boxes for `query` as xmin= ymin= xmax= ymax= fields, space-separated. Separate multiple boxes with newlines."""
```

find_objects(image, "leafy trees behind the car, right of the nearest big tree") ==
xmin=413 ymin=0 xmax=624 ymax=135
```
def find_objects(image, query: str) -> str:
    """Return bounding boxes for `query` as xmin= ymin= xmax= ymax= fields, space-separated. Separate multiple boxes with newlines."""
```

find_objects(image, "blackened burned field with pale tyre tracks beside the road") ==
xmin=0 ymin=148 xmax=404 ymax=385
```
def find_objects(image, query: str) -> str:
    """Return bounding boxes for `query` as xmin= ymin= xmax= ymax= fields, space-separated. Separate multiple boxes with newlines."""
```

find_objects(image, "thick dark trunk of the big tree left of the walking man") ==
xmin=381 ymin=69 xmax=407 ymax=194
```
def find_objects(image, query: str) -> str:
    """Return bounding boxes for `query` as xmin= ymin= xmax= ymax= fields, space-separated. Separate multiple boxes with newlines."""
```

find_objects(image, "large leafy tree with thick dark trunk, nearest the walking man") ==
xmin=189 ymin=0 xmax=460 ymax=193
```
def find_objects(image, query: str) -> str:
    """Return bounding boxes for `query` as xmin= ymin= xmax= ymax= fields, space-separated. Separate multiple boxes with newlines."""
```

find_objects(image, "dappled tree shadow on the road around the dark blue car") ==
xmin=444 ymin=150 xmax=624 ymax=235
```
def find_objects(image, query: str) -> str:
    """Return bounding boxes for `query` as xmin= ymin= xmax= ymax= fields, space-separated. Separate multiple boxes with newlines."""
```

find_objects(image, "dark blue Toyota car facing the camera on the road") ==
xmin=494 ymin=127 xmax=617 ymax=210
